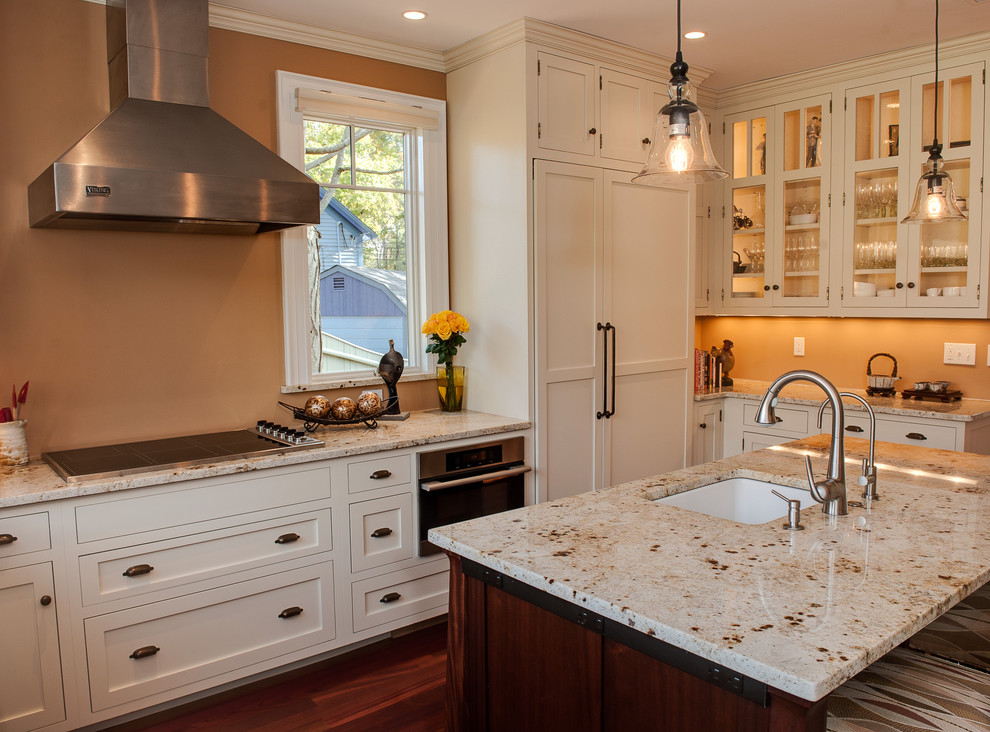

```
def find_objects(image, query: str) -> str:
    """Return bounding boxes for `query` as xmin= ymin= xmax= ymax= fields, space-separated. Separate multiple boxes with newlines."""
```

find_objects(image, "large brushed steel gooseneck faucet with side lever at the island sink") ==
xmin=756 ymin=370 xmax=849 ymax=516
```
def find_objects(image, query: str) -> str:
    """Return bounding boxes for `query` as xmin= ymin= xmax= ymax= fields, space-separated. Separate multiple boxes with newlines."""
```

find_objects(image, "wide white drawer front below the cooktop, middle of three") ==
xmin=79 ymin=509 xmax=333 ymax=605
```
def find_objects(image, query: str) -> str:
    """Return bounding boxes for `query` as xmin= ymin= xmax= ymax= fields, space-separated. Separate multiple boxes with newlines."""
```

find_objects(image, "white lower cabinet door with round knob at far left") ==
xmin=0 ymin=564 xmax=65 ymax=732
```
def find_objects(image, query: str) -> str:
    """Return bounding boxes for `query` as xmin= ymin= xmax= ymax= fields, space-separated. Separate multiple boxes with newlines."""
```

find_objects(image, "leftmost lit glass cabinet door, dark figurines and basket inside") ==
xmin=722 ymin=110 xmax=773 ymax=309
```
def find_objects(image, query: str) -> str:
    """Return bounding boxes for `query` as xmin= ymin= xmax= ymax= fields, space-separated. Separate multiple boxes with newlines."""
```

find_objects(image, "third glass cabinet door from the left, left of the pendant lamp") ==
xmin=842 ymin=79 xmax=912 ymax=308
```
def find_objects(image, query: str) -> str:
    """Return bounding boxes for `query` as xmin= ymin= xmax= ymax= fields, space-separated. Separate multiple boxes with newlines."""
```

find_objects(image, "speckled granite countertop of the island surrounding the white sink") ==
xmin=429 ymin=435 xmax=990 ymax=700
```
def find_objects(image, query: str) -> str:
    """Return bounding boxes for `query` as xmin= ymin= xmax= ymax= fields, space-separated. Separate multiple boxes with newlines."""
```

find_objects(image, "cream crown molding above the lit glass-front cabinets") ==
xmin=716 ymin=32 xmax=990 ymax=111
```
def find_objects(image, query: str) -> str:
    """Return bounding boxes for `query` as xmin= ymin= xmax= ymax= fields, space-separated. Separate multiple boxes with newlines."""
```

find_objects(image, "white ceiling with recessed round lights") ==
xmin=215 ymin=0 xmax=990 ymax=89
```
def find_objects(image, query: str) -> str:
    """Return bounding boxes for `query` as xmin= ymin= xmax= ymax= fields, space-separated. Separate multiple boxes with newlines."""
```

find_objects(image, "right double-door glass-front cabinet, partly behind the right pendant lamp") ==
xmin=842 ymin=64 xmax=983 ymax=309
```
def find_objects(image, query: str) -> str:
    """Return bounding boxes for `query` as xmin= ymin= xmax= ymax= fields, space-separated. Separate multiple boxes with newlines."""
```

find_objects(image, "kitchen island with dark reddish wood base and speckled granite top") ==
xmin=430 ymin=436 xmax=990 ymax=730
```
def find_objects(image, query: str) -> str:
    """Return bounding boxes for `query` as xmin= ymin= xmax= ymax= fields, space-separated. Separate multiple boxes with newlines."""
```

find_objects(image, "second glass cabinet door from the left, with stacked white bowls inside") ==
xmin=768 ymin=96 xmax=831 ymax=307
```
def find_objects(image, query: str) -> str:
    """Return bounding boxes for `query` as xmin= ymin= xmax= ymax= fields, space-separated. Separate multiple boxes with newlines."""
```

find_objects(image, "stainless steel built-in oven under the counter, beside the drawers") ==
xmin=419 ymin=437 xmax=531 ymax=557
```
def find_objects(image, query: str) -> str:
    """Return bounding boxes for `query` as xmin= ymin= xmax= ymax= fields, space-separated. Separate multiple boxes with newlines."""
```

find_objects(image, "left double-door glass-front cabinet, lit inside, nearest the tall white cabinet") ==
xmin=723 ymin=96 xmax=830 ymax=311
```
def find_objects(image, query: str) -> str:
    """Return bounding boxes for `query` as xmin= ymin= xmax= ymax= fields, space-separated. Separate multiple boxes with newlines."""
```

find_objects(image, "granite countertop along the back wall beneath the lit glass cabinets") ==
xmin=694 ymin=379 xmax=990 ymax=422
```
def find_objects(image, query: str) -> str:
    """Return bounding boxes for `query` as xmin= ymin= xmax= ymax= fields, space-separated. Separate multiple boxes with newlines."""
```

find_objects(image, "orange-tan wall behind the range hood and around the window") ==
xmin=0 ymin=0 xmax=445 ymax=455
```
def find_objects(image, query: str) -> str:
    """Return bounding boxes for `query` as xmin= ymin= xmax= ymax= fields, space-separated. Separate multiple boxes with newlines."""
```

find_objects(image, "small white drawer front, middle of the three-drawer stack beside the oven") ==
xmin=350 ymin=493 xmax=416 ymax=572
